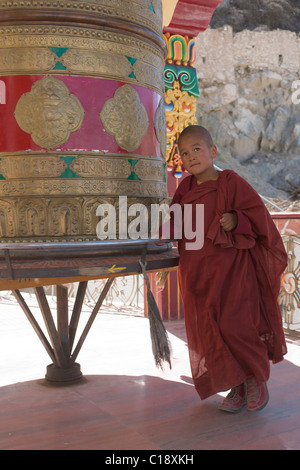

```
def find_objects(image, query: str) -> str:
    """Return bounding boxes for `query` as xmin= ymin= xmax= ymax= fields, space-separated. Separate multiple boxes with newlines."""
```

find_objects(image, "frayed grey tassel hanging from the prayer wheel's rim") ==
xmin=139 ymin=260 xmax=172 ymax=369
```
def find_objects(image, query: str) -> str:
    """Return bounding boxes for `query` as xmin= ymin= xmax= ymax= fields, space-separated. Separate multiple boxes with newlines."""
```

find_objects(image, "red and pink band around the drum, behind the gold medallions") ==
xmin=0 ymin=75 xmax=161 ymax=157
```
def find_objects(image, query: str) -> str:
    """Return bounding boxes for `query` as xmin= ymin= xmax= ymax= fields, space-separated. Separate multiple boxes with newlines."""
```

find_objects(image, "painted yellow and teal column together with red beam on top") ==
xmin=150 ymin=0 xmax=222 ymax=320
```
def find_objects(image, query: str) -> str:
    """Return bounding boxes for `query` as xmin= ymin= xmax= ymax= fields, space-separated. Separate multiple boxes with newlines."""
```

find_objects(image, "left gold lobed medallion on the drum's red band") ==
xmin=15 ymin=77 xmax=84 ymax=149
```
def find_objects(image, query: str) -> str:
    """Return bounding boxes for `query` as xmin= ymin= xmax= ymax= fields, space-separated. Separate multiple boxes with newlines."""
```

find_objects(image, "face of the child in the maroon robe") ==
xmin=179 ymin=133 xmax=217 ymax=182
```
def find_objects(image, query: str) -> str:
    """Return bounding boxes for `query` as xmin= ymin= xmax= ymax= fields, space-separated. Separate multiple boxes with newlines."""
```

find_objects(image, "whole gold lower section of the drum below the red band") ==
xmin=0 ymin=152 xmax=167 ymax=243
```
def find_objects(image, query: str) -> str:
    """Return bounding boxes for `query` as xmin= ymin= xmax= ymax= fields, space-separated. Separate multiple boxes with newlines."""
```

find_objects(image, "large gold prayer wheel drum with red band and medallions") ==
xmin=0 ymin=0 xmax=167 ymax=244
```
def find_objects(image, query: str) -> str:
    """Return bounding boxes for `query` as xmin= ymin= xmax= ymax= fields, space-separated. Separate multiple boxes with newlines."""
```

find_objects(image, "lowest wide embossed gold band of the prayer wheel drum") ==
xmin=0 ymin=194 xmax=166 ymax=243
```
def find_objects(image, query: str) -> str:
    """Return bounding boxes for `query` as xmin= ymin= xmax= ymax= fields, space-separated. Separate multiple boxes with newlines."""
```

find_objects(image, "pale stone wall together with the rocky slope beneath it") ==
xmin=195 ymin=26 xmax=300 ymax=197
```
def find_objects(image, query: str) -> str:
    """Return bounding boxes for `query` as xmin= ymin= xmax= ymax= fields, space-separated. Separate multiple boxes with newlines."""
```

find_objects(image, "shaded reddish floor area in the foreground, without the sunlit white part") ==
xmin=0 ymin=356 xmax=300 ymax=450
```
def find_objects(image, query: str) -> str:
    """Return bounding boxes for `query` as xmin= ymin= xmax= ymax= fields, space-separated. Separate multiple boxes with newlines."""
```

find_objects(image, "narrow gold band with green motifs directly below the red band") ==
xmin=0 ymin=151 xmax=166 ymax=185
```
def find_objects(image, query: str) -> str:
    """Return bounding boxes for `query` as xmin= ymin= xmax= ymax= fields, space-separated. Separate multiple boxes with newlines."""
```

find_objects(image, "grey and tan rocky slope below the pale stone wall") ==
xmin=198 ymin=63 xmax=300 ymax=201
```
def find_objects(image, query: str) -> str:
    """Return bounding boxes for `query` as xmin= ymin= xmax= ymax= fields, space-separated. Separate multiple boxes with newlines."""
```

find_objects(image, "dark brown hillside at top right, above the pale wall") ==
xmin=210 ymin=0 xmax=300 ymax=33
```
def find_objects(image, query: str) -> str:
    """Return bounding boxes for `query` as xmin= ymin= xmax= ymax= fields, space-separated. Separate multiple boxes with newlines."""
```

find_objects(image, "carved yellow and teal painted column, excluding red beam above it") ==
xmin=145 ymin=33 xmax=199 ymax=320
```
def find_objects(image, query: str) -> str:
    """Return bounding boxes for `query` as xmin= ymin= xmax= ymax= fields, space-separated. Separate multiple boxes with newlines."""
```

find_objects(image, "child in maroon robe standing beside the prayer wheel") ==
xmin=164 ymin=126 xmax=287 ymax=413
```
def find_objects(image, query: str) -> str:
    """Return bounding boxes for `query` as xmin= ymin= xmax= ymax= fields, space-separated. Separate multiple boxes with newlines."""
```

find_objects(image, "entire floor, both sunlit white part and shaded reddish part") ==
xmin=0 ymin=295 xmax=300 ymax=451
